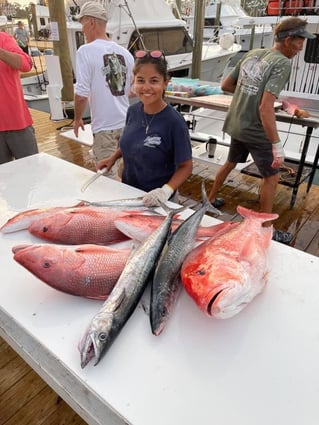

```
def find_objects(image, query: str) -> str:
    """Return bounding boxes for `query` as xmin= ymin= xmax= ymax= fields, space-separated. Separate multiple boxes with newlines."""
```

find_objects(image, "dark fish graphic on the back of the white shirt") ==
xmin=103 ymin=53 xmax=127 ymax=96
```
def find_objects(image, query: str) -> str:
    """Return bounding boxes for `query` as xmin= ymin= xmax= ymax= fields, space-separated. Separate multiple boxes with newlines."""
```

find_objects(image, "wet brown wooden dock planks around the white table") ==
xmin=0 ymin=110 xmax=319 ymax=425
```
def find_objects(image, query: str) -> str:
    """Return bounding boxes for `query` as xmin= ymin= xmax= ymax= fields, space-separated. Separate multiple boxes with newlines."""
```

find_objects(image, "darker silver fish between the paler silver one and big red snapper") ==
xmin=150 ymin=183 xmax=216 ymax=335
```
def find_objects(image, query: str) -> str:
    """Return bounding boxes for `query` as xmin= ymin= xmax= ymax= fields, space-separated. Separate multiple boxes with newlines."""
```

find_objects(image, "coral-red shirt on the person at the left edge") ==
xmin=0 ymin=32 xmax=33 ymax=131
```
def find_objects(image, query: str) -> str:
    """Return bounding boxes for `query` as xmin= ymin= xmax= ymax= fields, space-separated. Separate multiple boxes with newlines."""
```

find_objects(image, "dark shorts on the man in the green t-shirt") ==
xmin=228 ymin=138 xmax=279 ymax=177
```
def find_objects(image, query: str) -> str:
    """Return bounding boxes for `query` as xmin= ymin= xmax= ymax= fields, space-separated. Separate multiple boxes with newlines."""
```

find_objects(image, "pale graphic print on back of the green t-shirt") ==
xmin=238 ymin=56 xmax=270 ymax=96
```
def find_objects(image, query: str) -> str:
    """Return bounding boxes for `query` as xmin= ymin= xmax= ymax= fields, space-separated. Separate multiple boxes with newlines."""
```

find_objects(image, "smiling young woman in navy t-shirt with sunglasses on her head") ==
xmin=97 ymin=50 xmax=192 ymax=206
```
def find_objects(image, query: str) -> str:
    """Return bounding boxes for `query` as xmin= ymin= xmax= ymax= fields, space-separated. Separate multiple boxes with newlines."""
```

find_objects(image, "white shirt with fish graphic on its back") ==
xmin=75 ymin=39 xmax=134 ymax=134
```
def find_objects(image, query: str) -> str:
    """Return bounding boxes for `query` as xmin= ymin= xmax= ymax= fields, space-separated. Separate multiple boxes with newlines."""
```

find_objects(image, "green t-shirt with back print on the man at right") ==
xmin=223 ymin=49 xmax=291 ymax=142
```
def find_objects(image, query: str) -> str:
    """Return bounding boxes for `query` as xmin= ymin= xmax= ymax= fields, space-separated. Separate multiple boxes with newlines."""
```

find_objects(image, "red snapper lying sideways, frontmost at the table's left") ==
xmin=12 ymin=244 xmax=131 ymax=300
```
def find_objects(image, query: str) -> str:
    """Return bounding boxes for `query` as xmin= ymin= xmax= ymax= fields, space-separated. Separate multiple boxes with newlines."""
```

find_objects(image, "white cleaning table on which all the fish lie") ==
xmin=0 ymin=154 xmax=319 ymax=425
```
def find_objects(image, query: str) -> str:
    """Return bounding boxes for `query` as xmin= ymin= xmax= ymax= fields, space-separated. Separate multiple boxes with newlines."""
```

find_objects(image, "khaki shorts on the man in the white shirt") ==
xmin=92 ymin=128 xmax=123 ymax=178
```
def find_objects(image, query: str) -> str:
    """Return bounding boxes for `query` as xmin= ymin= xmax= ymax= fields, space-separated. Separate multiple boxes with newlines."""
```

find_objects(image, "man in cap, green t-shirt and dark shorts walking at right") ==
xmin=209 ymin=17 xmax=315 ymax=243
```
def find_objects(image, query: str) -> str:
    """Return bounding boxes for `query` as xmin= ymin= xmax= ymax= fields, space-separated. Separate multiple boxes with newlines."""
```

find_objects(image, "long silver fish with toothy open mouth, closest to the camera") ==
xmin=79 ymin=206 xmax=184 ymax=368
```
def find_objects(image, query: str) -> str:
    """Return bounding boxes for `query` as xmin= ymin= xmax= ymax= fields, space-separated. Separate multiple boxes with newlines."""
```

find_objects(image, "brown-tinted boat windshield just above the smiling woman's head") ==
xmin=129 ymin=28 xmax=193 ymax=56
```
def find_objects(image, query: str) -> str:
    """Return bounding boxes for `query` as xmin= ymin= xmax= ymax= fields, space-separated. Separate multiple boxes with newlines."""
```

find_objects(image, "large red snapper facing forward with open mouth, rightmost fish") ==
xmin=181 ymin=206 xmax=278 ymax=319
